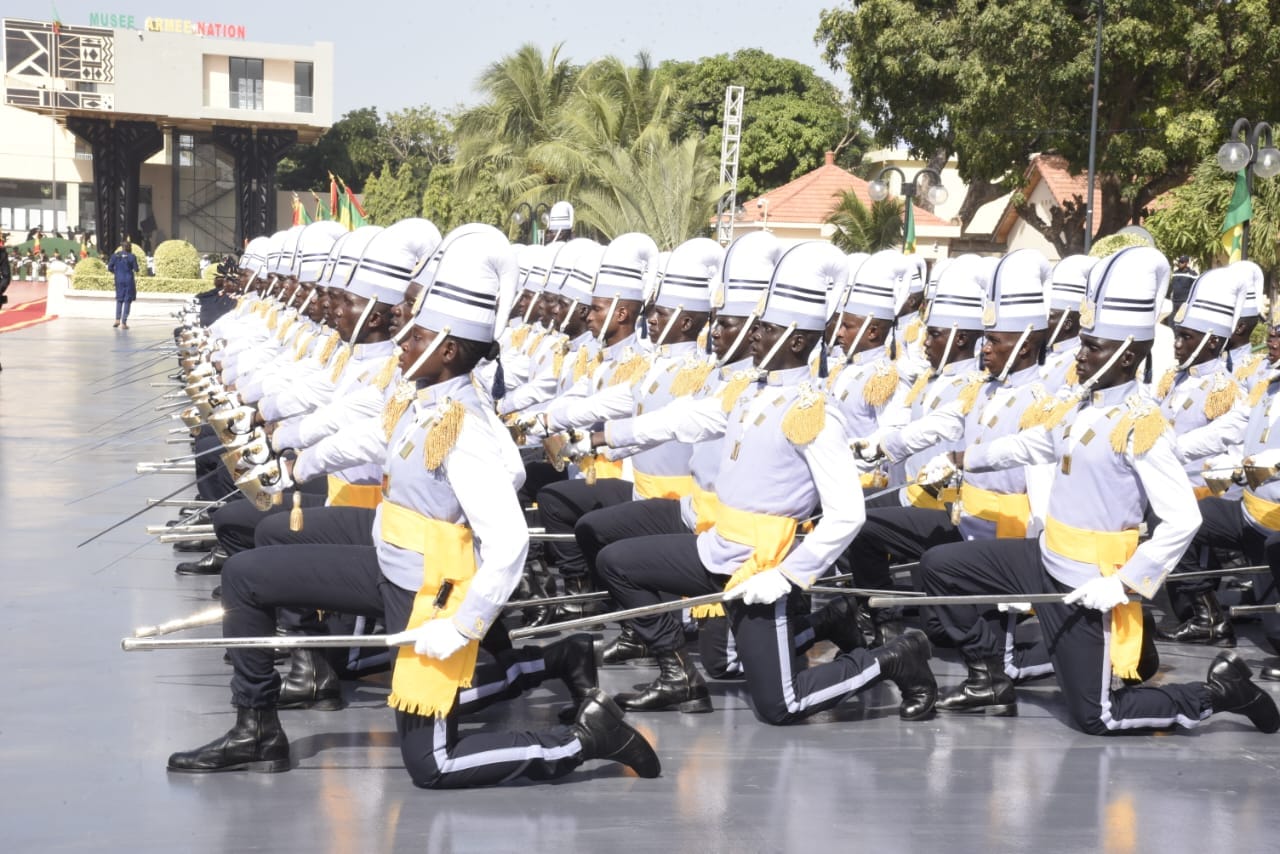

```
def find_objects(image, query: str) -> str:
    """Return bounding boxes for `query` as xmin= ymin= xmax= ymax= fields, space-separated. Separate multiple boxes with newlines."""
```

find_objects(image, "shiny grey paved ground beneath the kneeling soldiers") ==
xmin=0 ymin=319 xmax=1280 ymax=854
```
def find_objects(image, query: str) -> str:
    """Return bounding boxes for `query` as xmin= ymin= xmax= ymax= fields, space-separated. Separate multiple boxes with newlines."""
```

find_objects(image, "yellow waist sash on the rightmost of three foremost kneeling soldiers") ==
xmin=1044 ymin=516 xmax=1142 ymax=679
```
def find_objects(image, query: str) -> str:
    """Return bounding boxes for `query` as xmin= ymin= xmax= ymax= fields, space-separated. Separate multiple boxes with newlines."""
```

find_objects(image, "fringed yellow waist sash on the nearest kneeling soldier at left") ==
xmin=380 ymin=501 xmax=480 ymax=716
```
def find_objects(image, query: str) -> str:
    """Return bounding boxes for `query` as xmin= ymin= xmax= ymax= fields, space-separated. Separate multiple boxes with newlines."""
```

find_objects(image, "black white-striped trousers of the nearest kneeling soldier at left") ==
xmin=223 ymin=544 xmax=582 ymax=789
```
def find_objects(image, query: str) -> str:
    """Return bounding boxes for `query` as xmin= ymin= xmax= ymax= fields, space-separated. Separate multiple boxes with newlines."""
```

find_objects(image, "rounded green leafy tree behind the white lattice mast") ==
xmin=659 ymin=49 xmax=867 ymax=196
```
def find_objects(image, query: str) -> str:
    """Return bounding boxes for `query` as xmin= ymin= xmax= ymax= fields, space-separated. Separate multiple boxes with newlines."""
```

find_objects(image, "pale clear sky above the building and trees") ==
xmin=17 ymin=0 xmax=847 ymax=119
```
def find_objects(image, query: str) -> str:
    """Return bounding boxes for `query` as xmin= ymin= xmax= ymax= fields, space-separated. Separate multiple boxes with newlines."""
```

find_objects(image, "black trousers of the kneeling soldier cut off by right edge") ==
xmin=1165 ymin=497 xmax=1280 ymax=637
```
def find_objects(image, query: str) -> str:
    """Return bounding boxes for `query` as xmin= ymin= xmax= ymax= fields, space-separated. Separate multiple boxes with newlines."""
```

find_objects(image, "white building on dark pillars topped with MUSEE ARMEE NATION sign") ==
xmin=0 ymin=18 xmax=334 ymax=252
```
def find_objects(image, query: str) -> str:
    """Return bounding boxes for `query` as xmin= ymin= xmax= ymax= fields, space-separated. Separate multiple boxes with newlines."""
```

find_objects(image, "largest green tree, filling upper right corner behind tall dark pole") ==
xmin=817 ymin=0 xmax=1280 ymax=252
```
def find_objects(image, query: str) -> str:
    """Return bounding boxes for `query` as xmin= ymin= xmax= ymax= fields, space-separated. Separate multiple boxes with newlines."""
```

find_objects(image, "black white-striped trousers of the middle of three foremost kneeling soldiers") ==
xmin=598 ymin=534 xmax=879 ymax=723
